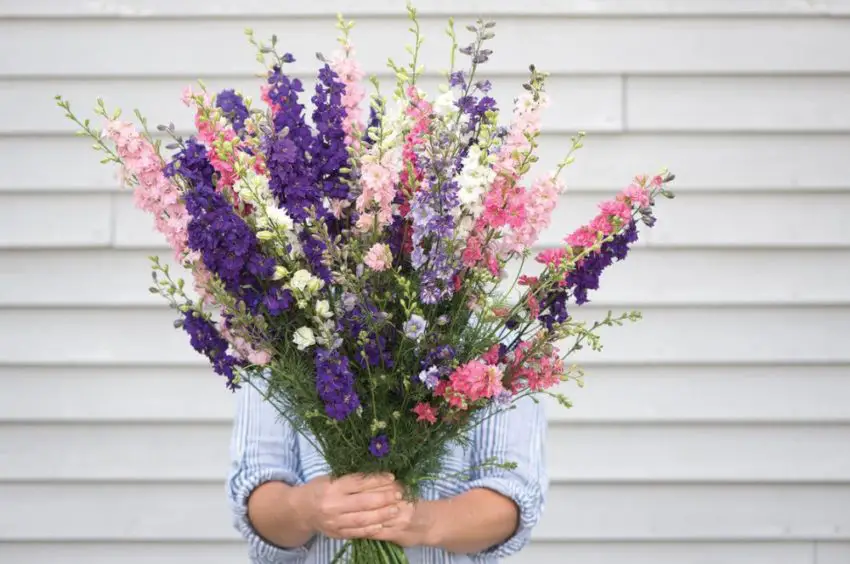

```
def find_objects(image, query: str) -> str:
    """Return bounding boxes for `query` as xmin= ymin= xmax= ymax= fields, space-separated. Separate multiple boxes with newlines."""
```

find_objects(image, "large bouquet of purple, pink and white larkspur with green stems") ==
xmin=57 ymin=8 xmax=673 ymax=563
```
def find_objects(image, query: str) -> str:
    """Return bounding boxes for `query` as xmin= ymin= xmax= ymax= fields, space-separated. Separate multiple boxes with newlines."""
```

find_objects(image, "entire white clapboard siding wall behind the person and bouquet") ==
xmin=0 ymin=0 xmax=850 ymax=564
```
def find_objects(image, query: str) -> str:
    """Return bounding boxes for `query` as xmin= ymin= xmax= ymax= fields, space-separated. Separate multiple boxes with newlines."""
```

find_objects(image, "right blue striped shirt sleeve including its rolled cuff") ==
xmin=465 ymin=397 xmax=549 ymax=562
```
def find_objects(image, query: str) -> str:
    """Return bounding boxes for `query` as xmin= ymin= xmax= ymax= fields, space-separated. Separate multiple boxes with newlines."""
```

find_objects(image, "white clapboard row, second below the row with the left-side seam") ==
xmin=0 ymin=304 xmax=850 ymax=365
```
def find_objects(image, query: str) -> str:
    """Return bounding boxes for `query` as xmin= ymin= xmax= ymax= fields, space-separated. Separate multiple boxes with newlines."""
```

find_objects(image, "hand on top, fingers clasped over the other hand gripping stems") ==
xmin=302 ymin=474 xmax=402 ymax=539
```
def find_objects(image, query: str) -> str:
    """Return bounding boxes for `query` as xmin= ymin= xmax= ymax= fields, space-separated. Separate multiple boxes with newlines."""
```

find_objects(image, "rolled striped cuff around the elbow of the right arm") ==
xmin=460 ymin=475 xmax=544 ymax=561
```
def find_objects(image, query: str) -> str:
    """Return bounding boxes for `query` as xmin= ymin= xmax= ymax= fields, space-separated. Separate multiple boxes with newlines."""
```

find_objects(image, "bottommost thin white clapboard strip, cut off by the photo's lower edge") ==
xmin=0 ymin=539 xmax=816 ymax=564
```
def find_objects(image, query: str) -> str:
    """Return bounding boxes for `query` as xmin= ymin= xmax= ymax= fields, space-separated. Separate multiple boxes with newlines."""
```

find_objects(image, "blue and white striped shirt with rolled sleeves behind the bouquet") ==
xmin=227 ymin=386 xmax=548 ymax=564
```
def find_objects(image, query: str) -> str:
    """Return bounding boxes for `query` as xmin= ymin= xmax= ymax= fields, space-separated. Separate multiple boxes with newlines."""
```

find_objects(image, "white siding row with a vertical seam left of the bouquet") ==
xmin=6 ymin=190 xmax=850 ymax=251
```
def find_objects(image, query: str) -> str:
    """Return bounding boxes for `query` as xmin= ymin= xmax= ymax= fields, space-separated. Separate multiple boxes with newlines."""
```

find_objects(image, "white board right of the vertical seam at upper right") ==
xmin=625 ymin=76 xmax=850 ymax=132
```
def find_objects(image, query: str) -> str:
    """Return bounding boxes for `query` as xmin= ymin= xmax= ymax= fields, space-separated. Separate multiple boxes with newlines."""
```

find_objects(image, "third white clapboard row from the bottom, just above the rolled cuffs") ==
xmin=0 ymin=422 xmax=850 ymax=483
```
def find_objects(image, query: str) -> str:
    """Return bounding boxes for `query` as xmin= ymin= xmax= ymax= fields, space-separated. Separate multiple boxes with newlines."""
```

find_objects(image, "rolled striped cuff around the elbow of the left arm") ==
xmin=228 ymin=469 xmax=307 ymax=564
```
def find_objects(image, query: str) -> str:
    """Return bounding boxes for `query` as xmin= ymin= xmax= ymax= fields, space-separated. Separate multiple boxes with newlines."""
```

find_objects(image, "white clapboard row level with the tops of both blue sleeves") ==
xmin=0 ymin=364 xmax=850 ymax=424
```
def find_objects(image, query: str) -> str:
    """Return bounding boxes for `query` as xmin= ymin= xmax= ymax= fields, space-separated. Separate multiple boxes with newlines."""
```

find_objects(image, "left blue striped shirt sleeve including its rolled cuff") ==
xmin=227 ymin=378 xmax=307 ymax=564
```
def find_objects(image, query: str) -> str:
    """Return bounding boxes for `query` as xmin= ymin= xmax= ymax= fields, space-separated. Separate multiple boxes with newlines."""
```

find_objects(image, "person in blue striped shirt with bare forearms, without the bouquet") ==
xmin=228 ymin=382 xmax=548 ymax=564
